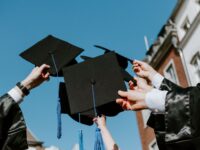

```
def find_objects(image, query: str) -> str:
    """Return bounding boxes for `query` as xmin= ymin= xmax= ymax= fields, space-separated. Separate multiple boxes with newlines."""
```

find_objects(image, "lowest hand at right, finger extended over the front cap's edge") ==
xmin=116 ymin=89 xmax=147 ymax=110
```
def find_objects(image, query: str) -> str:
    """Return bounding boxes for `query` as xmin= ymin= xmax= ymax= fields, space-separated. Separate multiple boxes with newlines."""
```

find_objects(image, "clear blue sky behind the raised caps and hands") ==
xmin=0 ymin=0 xmax=176 ymax=150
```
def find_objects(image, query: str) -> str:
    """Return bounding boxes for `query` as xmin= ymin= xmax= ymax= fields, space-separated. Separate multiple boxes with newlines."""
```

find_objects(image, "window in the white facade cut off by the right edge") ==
xmin=191 ymin=52 xmax=200 ymax=83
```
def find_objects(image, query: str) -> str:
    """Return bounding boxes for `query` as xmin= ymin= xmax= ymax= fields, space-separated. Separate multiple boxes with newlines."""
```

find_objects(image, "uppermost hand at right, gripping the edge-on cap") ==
xmin=133 ymin=60 xmax=157 ymax=81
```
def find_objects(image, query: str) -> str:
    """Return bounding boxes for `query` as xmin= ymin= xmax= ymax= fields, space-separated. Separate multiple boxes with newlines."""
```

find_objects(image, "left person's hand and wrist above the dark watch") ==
xmin=21 ymin=64 xmax=50 ymax=90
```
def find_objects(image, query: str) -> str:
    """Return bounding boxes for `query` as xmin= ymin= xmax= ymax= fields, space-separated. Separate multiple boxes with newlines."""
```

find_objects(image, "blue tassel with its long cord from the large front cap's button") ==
xmin=91 ymin=80 xmax=105 ymax=150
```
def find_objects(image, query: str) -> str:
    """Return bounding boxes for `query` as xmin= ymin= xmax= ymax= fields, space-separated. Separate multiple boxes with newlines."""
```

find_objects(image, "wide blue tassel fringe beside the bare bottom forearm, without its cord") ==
xmin=94 ymin=128 xmax=105 ymax=150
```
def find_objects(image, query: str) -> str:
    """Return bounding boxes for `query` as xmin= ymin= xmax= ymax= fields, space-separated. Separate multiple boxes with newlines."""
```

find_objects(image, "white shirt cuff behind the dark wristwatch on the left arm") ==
xmin=8 ymin=87 xmax=23 ymax=104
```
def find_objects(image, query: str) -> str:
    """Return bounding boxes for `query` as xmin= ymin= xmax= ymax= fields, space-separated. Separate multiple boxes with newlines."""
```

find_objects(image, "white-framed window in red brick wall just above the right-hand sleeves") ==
xmin=164 ymin=60 xmax=179 ymax=84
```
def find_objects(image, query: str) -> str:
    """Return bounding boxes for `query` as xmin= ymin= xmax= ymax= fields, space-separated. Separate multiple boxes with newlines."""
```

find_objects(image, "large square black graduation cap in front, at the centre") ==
xmin=63 ymin=53 xmax=126 ymax=117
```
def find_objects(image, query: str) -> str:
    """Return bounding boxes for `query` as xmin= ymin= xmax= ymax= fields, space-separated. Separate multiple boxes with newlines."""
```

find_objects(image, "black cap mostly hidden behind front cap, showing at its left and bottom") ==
xmin=59 ymin=82 xmax=93 ymax=125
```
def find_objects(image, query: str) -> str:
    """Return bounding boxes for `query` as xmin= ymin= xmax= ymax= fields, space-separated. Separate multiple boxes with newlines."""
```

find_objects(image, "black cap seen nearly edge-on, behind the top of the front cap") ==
xmin=94 ymin=45 xmax=133 ymax=69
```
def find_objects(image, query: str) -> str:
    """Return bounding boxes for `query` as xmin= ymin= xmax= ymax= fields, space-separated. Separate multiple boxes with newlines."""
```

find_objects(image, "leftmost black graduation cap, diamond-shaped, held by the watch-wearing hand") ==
xmin=20 ymin=35 xmax=83 ymax=76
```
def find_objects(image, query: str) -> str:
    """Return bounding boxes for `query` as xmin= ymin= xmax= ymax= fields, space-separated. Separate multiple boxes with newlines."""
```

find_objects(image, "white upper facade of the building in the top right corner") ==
xmin=172 ymin=0 xmax=200 ymax=86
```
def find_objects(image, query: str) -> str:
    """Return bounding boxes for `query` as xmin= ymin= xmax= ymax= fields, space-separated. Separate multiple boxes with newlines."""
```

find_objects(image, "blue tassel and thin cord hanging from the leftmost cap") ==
xmin=49 ymin=52 xmax=62 ymax=139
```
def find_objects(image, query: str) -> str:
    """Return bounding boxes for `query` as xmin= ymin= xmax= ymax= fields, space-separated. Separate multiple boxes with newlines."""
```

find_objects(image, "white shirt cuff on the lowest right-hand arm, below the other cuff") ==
xmin=145 ymin=89 xmax=167 ymax=112
